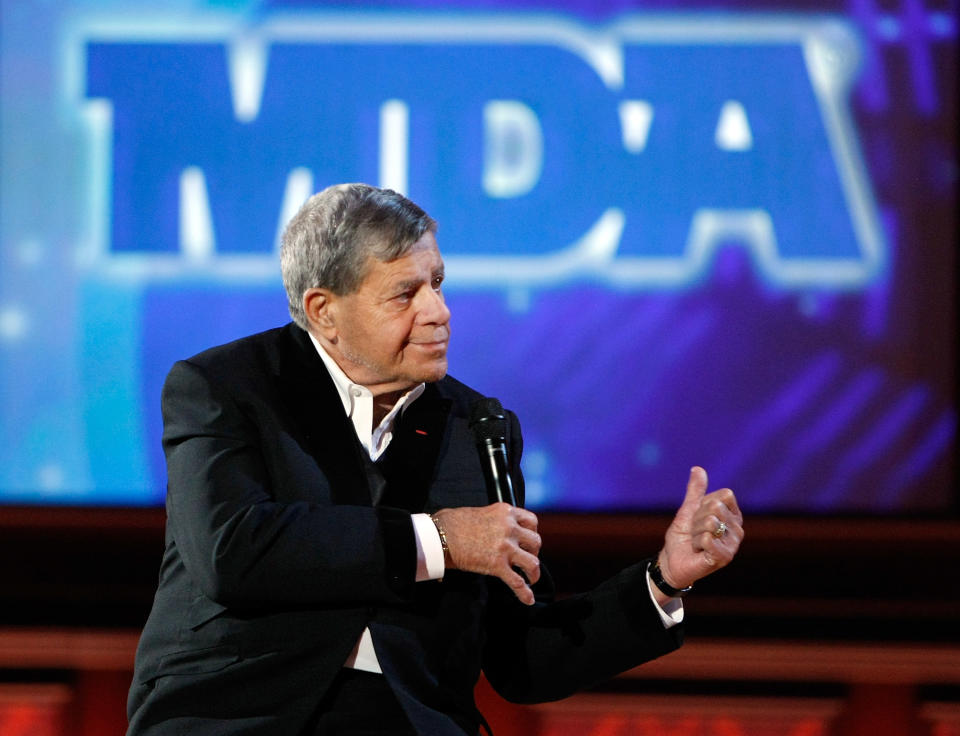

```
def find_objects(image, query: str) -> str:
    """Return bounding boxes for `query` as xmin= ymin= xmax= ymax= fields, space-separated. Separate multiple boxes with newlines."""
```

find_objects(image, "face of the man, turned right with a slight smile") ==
xmin=318 ymin=232 xmax=450 ymax=394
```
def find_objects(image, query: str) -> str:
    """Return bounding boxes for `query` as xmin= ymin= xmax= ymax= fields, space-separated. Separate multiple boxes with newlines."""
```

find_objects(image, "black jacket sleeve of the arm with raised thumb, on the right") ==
xmin=483 ymin=408 xmax=683 ymax=703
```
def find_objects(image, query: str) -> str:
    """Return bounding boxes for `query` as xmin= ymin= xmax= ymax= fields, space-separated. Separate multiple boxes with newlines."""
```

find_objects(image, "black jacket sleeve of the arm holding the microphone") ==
xmin=162 ymin=362 xmax=416 ymax=606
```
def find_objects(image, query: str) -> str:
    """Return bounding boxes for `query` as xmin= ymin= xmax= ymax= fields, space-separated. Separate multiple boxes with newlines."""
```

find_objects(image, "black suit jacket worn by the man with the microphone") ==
xmin=128 ymin=324 xmax=681 ymax=736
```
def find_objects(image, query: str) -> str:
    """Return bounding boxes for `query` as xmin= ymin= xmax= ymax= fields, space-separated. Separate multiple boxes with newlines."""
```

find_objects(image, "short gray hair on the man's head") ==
xmin=280 ymin=184 xmax=437 ymax=329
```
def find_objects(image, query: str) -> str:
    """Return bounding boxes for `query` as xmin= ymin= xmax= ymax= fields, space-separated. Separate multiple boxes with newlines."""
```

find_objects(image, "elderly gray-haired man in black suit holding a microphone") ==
xmin=129 ymin=184 xmax=743 ymax=736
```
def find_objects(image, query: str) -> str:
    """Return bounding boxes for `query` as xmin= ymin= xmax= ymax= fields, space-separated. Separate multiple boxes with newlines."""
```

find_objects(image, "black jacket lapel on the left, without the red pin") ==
xmin=277 ymin=324 xmax=370 ymax=506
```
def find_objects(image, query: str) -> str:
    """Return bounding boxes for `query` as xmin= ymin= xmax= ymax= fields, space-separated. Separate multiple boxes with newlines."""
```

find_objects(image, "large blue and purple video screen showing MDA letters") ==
xmin=0 ymin=0 xmax=958 ymax=514
